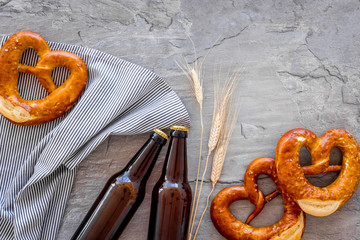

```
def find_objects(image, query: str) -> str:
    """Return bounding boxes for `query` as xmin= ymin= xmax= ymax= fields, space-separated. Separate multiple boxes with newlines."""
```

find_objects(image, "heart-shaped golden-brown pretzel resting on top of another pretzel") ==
xmin=275 ymin=129 xmax=360 ymax=216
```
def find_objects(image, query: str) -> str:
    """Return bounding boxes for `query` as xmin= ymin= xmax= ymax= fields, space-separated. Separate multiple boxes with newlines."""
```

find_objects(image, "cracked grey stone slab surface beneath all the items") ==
xmin=0 ymin=0 xmax=360 ymax=240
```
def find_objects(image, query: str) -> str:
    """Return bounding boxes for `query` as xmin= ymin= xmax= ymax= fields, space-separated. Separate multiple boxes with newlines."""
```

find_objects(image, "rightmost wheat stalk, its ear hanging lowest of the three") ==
xmin=194 ymin=69 xmax=240 ymax=239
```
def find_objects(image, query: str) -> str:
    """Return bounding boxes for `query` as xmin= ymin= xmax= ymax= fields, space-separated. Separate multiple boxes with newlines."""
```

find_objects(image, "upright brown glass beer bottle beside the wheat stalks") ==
xmin=148 ymin=126 xmax=192 ymax=240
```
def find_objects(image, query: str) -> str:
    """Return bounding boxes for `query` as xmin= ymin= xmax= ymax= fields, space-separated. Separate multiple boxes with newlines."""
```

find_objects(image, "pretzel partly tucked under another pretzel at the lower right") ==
xmin=210 ymin=157 xmax=305 ymax=240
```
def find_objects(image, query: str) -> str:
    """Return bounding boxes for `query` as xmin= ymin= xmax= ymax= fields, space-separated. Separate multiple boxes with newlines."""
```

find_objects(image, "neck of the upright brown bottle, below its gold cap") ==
xmin=163 ymin=136 xmax=187 ymax=182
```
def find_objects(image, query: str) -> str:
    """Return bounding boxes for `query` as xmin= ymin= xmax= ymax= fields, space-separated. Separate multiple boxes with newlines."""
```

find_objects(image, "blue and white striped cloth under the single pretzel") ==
xmin=0 ymin=36 xmax=189 ymax=240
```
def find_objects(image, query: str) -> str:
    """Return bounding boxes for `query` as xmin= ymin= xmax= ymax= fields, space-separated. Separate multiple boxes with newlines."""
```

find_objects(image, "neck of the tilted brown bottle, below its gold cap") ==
xmin=125 ymin=136 xmax=166 ymax=182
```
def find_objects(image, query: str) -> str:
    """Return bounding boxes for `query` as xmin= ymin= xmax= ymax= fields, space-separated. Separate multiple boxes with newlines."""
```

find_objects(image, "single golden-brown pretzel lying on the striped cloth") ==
xmin=0 ymin=31 xmax=87 ymax=125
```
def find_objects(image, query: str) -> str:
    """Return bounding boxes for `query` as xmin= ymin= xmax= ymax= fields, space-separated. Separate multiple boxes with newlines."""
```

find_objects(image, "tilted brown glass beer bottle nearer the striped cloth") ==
xmin=72 ymin=129 xmax=168 ymax=240
